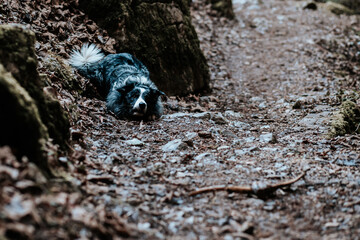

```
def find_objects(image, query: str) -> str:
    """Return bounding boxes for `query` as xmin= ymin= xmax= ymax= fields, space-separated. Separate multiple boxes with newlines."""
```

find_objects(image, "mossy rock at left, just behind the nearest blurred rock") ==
xmin=0 ymin=25 xmax=70 ymax=149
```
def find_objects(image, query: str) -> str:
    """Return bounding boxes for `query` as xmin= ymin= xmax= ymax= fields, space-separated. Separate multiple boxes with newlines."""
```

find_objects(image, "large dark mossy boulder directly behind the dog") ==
xmin=80 ymin=0 xmax=209 ymax=95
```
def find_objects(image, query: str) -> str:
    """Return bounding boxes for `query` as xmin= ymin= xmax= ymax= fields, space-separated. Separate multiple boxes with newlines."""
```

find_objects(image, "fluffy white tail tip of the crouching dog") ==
xmin=69 ymin=43 xmax=104 ymax=69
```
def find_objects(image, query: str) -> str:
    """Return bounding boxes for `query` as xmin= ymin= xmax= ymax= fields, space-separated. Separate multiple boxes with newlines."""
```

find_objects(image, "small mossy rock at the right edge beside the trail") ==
xmin=330 ymin=100 xmax=360 ymax=137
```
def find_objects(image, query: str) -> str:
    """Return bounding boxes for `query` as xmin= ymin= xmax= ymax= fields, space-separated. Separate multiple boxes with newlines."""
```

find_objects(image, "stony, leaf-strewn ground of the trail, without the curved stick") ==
xmin=0 ymin=0 xmax=360 ymax=240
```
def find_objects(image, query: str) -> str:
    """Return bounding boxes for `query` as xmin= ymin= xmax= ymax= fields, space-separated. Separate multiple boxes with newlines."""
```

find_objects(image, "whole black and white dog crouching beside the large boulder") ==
xmin=69 ymin=44 xmax=165 ymax=120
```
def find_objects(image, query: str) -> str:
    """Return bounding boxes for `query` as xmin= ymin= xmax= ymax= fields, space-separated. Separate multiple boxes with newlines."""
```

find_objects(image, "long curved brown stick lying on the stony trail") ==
xmin=189 ymin=171 xmax=306 ymax=196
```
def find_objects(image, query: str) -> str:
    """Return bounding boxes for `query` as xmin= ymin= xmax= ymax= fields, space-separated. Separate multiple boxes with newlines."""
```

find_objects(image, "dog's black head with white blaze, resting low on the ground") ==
xmin=117 ymin=82 xmax=165 ymax=118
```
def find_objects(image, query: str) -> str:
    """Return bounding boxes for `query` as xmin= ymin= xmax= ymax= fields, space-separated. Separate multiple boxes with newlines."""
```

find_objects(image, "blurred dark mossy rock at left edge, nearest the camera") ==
xmin=0 ymin=64 xmax=49 ymax=172
